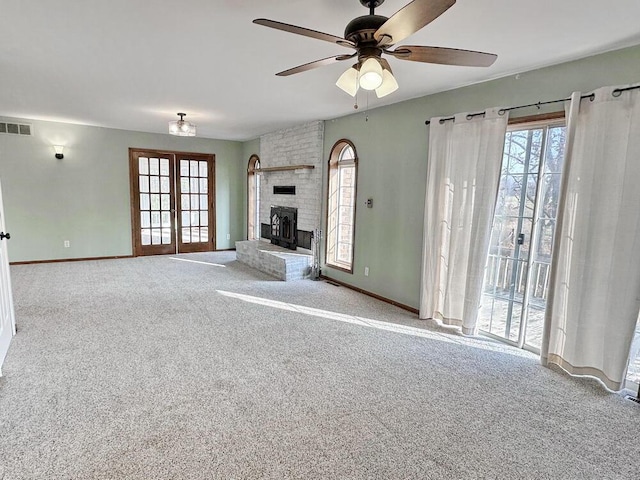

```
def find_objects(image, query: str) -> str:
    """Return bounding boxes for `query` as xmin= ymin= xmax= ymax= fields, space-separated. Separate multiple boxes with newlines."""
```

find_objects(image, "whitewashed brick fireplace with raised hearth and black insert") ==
xmin=236 ymin=122 xmax=324 ymax=281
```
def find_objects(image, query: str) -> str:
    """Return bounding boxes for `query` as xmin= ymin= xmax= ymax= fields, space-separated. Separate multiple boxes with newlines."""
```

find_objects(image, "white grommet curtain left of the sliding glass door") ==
xmin=420 ymin=109 xmax=508 ymax=334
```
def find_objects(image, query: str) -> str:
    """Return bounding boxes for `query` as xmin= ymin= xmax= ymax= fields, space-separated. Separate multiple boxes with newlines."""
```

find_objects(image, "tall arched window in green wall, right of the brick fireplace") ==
xmin=325 ymin=140 xmax=358 ymax=273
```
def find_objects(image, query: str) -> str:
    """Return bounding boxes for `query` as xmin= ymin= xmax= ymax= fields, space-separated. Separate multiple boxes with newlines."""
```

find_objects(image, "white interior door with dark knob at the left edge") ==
xmin=0 ymin=179 xmax=16 ymax=376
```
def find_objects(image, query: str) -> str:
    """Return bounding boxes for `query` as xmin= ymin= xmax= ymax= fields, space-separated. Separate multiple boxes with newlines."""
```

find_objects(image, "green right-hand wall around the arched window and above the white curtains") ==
xmin=322 ymin=46 xmax=640 ymax=308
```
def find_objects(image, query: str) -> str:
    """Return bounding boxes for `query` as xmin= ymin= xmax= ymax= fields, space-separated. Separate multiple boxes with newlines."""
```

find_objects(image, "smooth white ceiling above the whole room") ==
xmin=0 ymin=0 xmax=640 ymax=140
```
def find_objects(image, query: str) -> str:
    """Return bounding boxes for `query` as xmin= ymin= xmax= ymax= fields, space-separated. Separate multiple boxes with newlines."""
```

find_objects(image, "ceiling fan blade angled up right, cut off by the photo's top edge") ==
xmin=373 ymin=0 xmax=456 ymax=45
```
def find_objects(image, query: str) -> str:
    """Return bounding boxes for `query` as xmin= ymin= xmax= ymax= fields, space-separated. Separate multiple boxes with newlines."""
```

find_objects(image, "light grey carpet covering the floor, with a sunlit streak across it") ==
xmin=0 ymin=252 xmax=640 ymax=480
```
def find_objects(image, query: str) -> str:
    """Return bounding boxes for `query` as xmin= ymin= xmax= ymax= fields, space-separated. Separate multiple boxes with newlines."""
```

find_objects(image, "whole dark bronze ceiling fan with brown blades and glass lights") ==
xmin=253 ymin=0 xmax=498 ymax=98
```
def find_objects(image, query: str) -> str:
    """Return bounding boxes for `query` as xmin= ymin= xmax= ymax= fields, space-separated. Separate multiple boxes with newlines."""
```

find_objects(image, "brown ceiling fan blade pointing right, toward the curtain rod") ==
xmin=385 ymin=45 xmax=498 ymax=67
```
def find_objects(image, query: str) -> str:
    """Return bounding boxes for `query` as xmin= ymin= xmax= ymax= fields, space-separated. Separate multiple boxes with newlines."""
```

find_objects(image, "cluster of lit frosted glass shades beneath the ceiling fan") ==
xmin=336 ymin=57 xmax=398 ymax=98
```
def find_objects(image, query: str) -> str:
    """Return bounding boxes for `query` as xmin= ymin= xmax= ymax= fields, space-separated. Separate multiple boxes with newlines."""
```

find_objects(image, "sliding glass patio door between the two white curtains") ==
xmin=478 ymin=120 xmax=565 ymax=351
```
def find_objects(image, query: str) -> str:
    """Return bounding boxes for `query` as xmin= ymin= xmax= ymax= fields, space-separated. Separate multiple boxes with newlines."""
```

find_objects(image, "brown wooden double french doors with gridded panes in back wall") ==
xmin=129 ymin=149 xmax=215 ymax=256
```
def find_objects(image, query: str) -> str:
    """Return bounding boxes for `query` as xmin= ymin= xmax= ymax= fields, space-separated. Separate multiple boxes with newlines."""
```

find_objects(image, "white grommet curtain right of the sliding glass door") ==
xmin=541 ymin=87 xmax=640 ymax=390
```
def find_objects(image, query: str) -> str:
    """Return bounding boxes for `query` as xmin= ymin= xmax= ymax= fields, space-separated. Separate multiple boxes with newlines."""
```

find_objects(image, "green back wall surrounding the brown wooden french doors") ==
xmin=0 ymin=118 xmax=246 ymax=262
